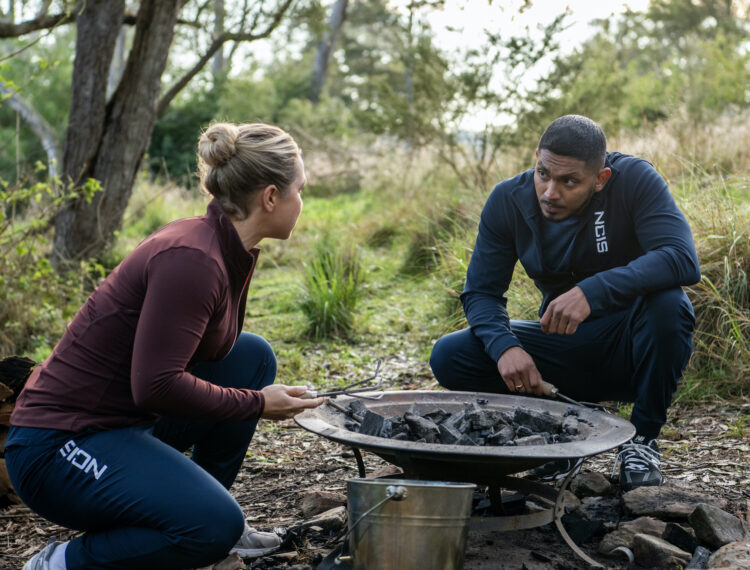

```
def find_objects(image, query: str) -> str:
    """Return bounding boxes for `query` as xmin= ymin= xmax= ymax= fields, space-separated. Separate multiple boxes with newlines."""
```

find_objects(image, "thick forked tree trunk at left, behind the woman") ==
xmin=51 ymin=0 xmax=182 ymax=268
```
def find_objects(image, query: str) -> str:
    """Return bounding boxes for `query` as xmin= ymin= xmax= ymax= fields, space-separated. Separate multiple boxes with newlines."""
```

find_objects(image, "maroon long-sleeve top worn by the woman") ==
xmin=11 ymin=200 xmax=265 ymax=432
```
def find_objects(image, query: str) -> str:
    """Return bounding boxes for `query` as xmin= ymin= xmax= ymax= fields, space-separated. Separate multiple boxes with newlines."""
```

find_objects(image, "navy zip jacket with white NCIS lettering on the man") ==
xmin=461 ymin=153 xmax=700 ymax=362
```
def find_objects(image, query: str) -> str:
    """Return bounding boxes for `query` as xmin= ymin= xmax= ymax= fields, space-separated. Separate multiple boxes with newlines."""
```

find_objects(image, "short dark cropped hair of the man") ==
xmin=538 ymin=115 xmax=607 ymax=172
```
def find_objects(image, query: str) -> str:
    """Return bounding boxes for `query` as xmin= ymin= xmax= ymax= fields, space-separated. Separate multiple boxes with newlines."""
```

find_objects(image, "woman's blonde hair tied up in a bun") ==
xmin=198 ymin=123 xmax=302 ymax=220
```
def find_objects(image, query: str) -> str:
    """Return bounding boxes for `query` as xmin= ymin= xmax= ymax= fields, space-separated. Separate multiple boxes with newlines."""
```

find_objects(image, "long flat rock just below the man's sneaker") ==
xmin=622 ymin=485 xmax=726 ymax=520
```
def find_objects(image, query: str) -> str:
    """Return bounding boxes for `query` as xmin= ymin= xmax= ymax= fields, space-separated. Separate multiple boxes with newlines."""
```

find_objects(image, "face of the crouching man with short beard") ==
xmin=534 ymin=149 xmax=611 ymax=221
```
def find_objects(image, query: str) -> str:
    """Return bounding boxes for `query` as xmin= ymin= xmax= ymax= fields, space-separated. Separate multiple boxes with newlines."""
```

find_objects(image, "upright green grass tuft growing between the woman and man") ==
xmin=301 ymin=240 xmax=363 ymax=340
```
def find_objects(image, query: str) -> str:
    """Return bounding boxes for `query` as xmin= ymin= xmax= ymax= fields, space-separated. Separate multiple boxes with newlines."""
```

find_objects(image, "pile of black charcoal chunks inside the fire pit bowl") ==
xmin=344 ymin=399 xmax=592 ymax=446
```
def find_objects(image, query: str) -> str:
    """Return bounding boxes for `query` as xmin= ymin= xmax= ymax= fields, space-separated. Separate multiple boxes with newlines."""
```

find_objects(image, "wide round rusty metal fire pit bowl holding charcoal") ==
xmin=294 ymin=390 xmax=635 ymax=484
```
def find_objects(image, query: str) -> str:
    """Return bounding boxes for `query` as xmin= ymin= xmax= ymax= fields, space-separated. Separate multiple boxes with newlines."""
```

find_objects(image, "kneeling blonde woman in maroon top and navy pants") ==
xmin=5 ymin=123 xmax=323 ymax=570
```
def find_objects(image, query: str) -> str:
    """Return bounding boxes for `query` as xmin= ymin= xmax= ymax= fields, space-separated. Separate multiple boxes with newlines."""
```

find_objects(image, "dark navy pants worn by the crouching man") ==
xmin=430 ymin=288 xmax=695 ymax=440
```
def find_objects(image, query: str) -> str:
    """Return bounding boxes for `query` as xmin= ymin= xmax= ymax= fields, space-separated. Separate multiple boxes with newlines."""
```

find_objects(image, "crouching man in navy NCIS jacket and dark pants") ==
xmin=430 ymin=115 xmax=700 ymax=490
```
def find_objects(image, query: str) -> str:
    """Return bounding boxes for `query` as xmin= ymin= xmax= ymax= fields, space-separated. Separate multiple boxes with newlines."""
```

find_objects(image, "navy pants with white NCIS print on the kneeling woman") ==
xmin=5 ymin=333 xmax=276 ymax=570
